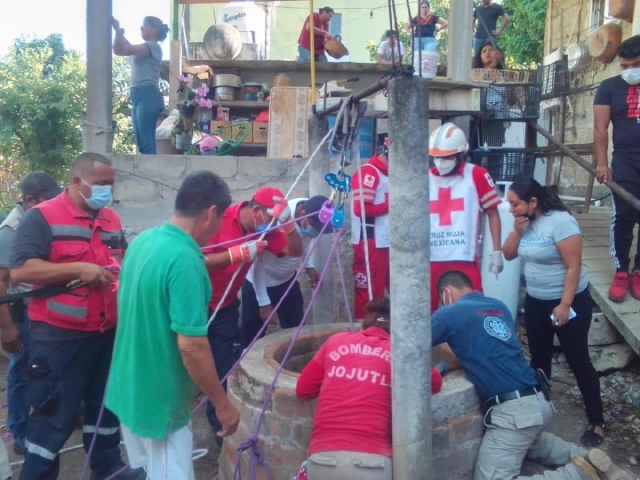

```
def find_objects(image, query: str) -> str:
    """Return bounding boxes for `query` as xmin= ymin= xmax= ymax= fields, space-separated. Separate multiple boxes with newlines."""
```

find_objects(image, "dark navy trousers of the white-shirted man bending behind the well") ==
xmin=241 ymin=275 xmax=304 ymax=349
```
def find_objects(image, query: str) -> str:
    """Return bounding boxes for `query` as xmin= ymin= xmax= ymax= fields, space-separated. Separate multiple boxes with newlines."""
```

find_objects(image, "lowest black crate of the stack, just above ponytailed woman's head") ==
xmin=471 ymin=148 xmax=535 ymax=182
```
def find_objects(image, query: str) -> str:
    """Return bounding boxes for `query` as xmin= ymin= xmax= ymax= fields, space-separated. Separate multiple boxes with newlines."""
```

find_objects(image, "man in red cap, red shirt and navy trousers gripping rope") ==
xmin=205 ymin=187 xmax=303 ymax=443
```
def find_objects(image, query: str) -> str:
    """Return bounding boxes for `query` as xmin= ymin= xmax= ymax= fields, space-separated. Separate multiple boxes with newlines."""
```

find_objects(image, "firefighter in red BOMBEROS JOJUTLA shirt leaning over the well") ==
xmin=296 ymin=297 xmax=442 ymax=480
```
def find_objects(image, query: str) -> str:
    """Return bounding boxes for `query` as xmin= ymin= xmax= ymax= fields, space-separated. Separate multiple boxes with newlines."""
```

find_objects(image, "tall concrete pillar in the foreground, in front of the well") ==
xmin=388 ymin=77 xmax=432 ymax=480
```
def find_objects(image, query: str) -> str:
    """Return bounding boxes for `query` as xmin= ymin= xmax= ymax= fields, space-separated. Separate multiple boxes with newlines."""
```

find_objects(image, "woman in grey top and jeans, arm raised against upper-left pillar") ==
xmin=111 ymin=17 xmax=169 ymax=155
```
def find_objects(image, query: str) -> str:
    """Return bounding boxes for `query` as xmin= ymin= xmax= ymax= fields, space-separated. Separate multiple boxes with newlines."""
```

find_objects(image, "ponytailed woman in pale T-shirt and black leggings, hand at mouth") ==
xmin=502 ymin=177 xmax=606 ymax=447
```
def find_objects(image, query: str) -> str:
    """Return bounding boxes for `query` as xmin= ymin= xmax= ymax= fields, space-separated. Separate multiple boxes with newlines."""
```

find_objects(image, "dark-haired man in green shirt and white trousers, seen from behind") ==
xmin=106 ymin=171 xmax=240 ymax=480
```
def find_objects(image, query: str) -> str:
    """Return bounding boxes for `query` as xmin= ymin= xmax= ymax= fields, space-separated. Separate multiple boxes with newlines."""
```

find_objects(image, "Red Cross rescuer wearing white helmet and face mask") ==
xmin=429 ymin=123 xmax=504 ymax=312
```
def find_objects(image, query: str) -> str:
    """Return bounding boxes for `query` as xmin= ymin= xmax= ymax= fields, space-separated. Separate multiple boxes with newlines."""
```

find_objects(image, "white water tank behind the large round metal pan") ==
xmin=218 ymin=0 xmax=267 ymax=60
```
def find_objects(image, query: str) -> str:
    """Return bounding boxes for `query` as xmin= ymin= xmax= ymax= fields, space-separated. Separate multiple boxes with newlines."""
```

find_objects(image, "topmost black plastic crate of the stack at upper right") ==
xmin=480 ymin=83 xmax=542 ymax=121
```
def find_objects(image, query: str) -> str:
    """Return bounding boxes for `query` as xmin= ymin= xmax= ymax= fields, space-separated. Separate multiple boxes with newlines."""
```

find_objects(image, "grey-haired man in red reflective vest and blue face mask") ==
xmin=10 ymin=153 xmax=146 ymax=480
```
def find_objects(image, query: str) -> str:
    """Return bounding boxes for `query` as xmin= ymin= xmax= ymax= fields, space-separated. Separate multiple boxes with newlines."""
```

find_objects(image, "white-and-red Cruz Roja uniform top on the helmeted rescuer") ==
xmin=429 ymin=162 xmax=501 ymax=262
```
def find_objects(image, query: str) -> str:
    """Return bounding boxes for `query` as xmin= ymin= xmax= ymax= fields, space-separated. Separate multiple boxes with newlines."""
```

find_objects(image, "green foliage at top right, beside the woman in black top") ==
xmin=498 ymin=0 xmax=547 ymax=69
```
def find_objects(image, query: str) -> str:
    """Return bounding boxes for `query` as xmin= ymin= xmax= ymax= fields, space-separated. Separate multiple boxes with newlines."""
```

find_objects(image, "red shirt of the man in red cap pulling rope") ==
xmin=206 ymin=202 xmax=288 ymax=310
